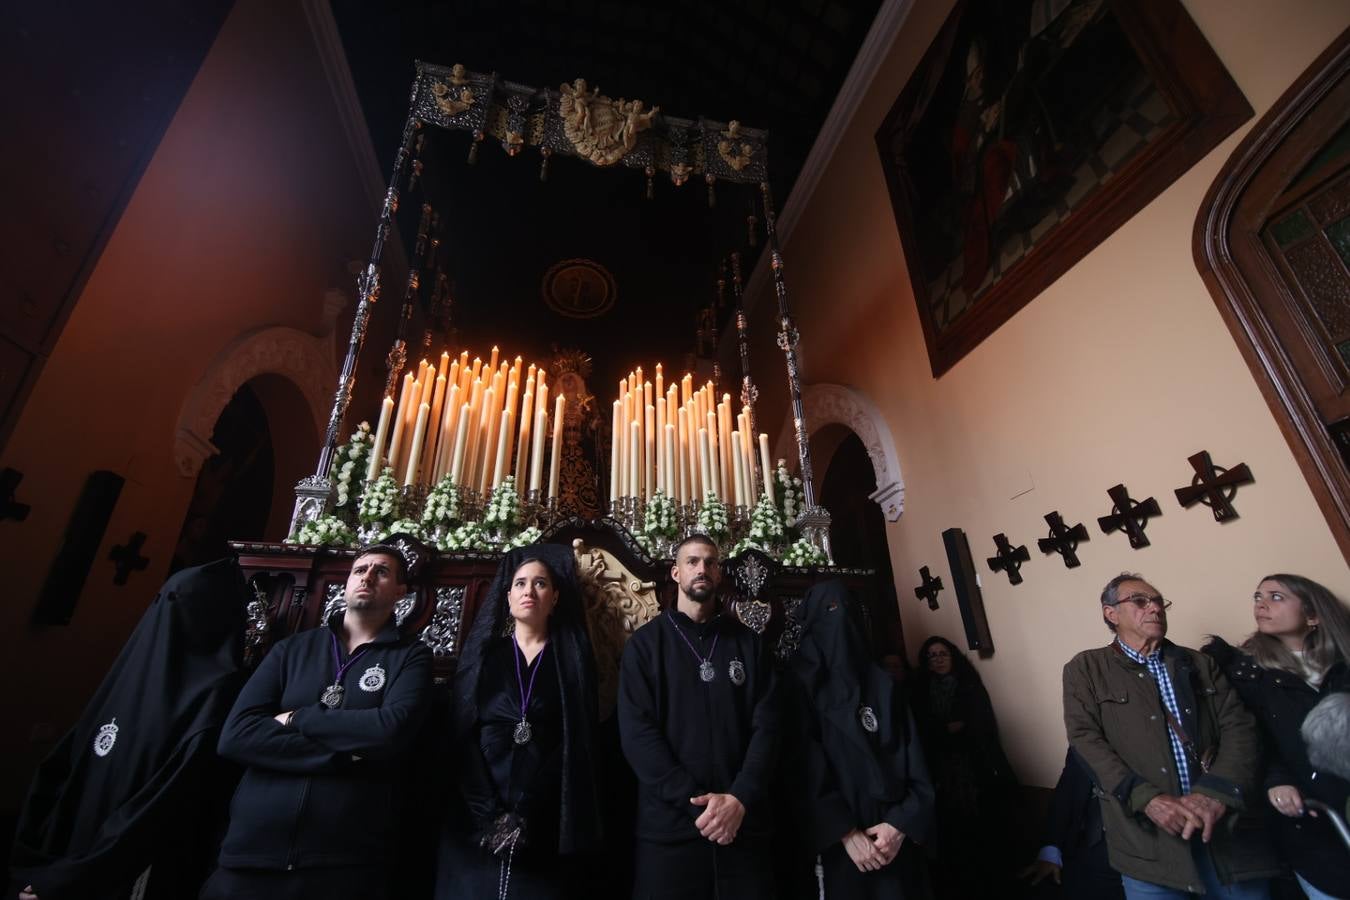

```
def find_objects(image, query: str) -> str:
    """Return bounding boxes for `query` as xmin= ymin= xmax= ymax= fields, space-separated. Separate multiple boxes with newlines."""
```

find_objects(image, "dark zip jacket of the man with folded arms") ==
xmin=220 ymin=613 xmax=431 ymax=869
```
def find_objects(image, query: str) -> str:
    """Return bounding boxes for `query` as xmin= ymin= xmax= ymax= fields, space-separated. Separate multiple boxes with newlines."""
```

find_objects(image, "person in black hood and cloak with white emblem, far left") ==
xmin=8 ymin=560 xmax=248 ymax=900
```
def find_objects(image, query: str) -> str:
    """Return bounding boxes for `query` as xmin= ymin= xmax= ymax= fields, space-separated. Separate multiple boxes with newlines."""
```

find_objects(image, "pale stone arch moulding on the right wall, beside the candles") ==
xmin=778 ymin=385 xmax=905 ymax=522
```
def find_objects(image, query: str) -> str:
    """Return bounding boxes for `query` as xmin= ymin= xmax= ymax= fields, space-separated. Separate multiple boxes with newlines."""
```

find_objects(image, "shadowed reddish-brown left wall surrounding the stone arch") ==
xmin=0 ymin=0 xmax=378 ymax=811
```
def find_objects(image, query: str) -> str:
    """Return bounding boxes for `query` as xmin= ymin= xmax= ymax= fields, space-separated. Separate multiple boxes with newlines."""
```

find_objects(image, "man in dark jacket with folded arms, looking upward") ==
xmin=201 ymin=544 xmax=431 ymax=900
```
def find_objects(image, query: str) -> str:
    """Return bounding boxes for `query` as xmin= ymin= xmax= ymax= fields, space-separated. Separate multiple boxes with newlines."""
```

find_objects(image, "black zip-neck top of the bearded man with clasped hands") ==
xmin=618 ymin=610 xmax=779 ymax=842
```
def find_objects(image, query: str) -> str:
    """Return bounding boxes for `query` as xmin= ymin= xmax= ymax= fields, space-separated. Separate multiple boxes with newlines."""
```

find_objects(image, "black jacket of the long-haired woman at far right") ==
xmin=1203 ymin=638 xmax=1350 ymax=897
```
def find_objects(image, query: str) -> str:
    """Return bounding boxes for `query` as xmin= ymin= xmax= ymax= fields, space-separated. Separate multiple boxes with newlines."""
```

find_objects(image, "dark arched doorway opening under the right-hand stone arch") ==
xmin=811 ymin=425 xmax=905 ymax=666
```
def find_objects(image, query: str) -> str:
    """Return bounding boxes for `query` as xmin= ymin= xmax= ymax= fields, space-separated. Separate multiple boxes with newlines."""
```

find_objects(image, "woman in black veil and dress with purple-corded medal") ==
xmin=436 ymin=544 xmax=601 ymax=900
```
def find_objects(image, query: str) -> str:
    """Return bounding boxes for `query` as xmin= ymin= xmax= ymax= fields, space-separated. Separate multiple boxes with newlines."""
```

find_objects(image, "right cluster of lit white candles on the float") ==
xmin=609 ymin=363 xmax=774 ymax=506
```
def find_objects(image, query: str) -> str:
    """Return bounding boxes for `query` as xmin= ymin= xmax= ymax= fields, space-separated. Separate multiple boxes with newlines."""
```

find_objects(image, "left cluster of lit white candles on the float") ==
xmin=366 ymin=347 xmax=567 ymax=498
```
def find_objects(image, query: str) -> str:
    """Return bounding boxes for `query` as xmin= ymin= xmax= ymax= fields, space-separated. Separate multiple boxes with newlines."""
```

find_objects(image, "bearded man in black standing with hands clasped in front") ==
xmin=618 ymin=534 xmax=779 ymax=900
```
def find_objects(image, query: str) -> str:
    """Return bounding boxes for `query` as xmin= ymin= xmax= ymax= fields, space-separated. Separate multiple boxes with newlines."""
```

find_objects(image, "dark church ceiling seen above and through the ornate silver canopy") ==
xmin=332 ymin=0 xmax=879 ymax=397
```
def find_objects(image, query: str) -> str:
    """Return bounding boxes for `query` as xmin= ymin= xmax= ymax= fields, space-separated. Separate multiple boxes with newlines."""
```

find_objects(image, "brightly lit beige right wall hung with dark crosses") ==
xmin=753 ymin=0 xmax=1350 ymax=785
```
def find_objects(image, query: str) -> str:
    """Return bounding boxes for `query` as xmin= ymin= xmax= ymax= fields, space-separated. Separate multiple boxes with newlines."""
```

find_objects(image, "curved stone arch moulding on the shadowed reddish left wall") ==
xmin=173 ymin=327 xmax=338 ymax=478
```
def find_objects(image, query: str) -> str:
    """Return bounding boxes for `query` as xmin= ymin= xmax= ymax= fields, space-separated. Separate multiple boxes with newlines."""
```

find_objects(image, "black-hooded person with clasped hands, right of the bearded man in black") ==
xmin=786 ymin=580 xmax=934 ymax=900
